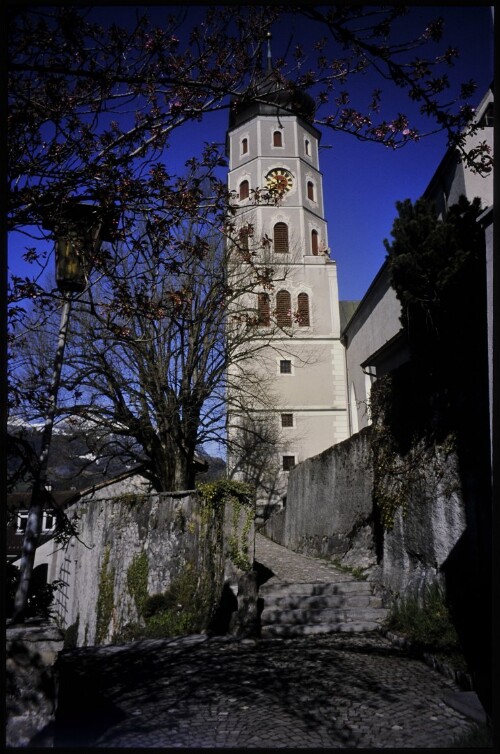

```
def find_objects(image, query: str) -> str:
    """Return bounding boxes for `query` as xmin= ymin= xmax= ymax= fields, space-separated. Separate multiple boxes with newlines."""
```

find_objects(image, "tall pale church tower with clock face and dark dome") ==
xmin=226 ymin=45 xmax=348 ymax=510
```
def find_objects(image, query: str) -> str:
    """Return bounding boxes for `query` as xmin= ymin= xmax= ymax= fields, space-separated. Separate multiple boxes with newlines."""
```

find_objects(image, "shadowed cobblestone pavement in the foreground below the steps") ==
xmin=55 ymin=542 xmax=472 ymax=750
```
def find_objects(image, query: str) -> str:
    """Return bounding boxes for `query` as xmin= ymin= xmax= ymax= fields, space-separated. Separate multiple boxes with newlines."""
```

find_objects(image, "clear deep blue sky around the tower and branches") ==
xmin=9 ymin=5 xmax=493 ymax=299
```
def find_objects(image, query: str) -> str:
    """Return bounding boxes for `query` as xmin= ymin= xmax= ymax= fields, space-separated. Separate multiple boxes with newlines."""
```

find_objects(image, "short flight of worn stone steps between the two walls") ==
xmin=259 ymin=579 xmax=387 ymax=637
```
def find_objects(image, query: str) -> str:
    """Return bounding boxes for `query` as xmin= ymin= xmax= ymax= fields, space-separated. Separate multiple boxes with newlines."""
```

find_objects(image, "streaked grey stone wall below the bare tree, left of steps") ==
xmin=35 ymin=492 xmax=254 ymax=646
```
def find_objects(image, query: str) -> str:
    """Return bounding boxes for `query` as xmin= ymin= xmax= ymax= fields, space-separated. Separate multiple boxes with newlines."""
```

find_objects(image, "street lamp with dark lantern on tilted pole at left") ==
xmin=12 ymin=201 xmax=117 ymax=623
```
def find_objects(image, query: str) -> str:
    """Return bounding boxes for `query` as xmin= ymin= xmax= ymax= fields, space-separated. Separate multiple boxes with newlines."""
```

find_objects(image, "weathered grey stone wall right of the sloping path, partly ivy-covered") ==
xmin=260 ymin=427 xmax=466 ymax=594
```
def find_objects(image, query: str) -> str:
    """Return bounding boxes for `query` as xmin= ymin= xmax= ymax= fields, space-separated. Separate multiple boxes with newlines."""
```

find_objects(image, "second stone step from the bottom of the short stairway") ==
xmin=260 ymin=606 xmax=387 ymax=626
